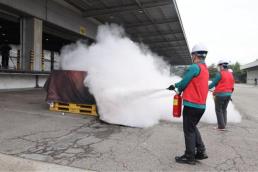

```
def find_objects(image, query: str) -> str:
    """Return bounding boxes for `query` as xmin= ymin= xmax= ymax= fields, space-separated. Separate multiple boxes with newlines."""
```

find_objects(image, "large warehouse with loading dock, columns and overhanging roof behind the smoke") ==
xmin=0 ymin=0 xmax=191 ymax=89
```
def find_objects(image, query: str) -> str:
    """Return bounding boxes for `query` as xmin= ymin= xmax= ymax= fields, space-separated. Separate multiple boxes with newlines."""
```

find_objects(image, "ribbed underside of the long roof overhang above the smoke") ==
xmin=64 ymin=0 xmax=191 ymax=65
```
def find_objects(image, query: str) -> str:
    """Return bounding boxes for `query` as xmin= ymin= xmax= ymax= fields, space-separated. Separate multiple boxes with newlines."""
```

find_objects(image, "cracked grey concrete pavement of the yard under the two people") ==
xmin=0 ymin=85 xmax=258 ymax=171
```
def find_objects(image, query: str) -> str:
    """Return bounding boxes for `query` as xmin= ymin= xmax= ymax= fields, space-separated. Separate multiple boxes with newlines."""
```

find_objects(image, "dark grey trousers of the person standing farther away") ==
xmin=215 ymin=96 xmax=231 ymax=129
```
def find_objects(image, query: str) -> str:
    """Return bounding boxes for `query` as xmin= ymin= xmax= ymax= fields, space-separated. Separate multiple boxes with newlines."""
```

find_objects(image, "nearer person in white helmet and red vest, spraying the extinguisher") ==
xmin=168 ymin=44 xmax=209 ymax=165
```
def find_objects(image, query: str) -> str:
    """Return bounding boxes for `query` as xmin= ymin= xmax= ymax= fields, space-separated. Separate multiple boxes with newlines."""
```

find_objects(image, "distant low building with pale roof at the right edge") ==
xmin=240 ymin=59 xmax=258 ymax=84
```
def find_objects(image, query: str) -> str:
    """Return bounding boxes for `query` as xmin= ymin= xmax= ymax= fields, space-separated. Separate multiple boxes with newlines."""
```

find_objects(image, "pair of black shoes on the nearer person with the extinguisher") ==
xmin=175 ymin=151 xmax=208 ymax=165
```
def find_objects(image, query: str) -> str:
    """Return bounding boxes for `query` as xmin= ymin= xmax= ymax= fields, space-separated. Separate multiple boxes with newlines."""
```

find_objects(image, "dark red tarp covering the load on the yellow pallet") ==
xmin=44 ymin=70 xmax=95 ymax=104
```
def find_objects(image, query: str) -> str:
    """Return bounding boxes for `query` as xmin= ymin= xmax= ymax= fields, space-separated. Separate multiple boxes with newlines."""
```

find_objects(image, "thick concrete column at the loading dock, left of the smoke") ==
xmin=20 ymin=17 xmax=43 ymax=71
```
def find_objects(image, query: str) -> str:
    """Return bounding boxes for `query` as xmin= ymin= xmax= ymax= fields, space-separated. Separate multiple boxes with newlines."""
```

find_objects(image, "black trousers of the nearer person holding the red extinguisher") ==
xmin=183 ymin=106 xmax=205 ymax=157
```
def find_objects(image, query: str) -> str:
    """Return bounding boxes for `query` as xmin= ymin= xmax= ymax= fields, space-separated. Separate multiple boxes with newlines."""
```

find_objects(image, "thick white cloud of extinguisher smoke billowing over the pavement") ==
xmin=61 ymin=24 xmax=241 ymax=127
